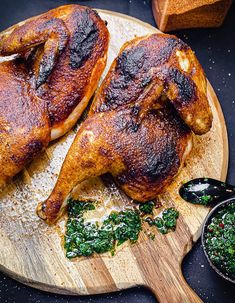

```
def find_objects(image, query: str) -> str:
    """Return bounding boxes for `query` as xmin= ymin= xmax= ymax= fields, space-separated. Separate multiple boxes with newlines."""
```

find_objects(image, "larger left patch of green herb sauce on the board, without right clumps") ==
xmin=64 ymin=200 xmax=141 ymax=258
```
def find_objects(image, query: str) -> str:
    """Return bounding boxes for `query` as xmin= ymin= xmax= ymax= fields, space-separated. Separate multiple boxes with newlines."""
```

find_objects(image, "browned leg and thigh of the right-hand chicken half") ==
xmin=37 ymin=105 xmax=191 ymax=224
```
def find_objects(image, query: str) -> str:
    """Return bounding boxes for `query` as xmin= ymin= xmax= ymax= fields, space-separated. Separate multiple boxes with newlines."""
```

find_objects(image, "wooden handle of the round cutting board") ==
xmin=133 ymin=240 xmax=203 ymax=303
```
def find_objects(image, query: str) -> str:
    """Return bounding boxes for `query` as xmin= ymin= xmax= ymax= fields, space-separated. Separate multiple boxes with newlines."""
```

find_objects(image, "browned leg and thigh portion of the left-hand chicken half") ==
xmin=0 ymin=61 xmax=50 ymax=187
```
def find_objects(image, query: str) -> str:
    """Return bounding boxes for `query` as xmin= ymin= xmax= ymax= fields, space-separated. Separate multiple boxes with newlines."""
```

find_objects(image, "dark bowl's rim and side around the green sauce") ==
xmin=201 ymin=196 xmax=235 ymax=283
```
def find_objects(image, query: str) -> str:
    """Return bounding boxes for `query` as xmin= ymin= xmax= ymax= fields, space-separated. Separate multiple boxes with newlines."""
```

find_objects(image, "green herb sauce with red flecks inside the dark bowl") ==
xmin=205 ymin=202 xmax=235 ymax=279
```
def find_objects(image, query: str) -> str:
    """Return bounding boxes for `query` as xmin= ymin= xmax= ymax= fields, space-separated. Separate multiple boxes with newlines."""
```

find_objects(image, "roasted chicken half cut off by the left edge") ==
xmin=0 ymin=5 xmax=109 ymax=187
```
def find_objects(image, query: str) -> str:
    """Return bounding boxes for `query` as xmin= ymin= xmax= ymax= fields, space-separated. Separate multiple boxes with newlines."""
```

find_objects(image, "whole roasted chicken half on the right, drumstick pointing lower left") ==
xmin=37 ymin=34 xmax=212 ymax=224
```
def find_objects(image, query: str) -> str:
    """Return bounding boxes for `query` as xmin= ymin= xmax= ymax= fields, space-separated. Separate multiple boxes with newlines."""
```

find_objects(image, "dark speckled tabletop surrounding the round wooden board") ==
xmin=0 ymin=0 xmax=235 ymax=303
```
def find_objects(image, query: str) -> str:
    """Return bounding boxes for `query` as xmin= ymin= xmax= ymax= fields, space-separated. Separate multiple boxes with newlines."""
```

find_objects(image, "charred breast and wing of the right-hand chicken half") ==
xmin=92 ymin=34 xmax=212 ymax=135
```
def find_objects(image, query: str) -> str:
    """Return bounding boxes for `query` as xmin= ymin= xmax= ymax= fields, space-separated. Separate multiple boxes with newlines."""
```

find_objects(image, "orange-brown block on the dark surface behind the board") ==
xmin=152 ymin=0 xmax=232 ymax=32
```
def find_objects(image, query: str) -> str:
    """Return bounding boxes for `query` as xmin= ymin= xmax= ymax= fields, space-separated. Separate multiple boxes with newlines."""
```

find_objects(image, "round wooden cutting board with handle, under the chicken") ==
xmin=0 ymin=10 xmax=228 ymax=302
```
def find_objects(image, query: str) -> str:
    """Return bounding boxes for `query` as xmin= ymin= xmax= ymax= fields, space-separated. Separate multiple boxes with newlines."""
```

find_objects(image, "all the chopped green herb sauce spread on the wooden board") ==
xmin=64 ymin=199 xmax=179 ymax=259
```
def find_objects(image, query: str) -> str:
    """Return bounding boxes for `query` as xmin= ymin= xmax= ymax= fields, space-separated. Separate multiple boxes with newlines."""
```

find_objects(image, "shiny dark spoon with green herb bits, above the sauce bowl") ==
xmin=179 ymin=178 xmax=235 ymax=205
